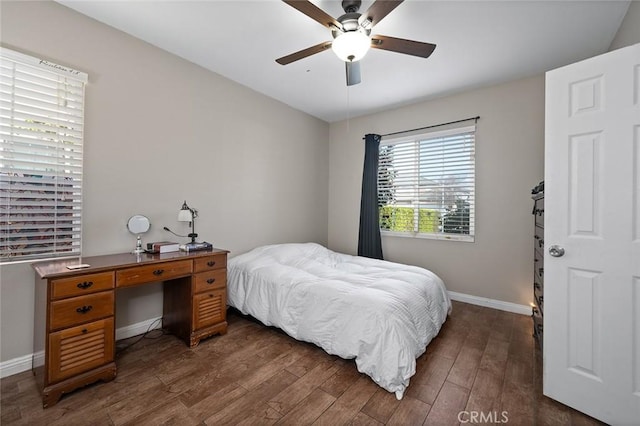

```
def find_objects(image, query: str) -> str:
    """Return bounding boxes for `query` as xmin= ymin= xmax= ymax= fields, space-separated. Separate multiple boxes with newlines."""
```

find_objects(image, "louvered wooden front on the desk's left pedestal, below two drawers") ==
xmin=48 ymin=317 xmax=114 ymax=383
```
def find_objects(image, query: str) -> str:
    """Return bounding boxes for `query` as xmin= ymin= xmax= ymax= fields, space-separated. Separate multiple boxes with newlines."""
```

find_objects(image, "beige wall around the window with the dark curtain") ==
xmin=329 ymin=76 xmax=544 ymax=305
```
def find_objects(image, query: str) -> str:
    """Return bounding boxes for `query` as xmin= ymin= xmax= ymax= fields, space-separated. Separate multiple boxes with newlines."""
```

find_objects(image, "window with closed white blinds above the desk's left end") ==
xmin=0 ymin=48 xmax=87 ymax=262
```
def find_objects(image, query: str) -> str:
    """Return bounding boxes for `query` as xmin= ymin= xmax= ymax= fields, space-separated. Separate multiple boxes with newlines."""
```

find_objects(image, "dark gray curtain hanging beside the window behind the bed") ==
xmin=358 ymin=134 xmax=382 ymax=259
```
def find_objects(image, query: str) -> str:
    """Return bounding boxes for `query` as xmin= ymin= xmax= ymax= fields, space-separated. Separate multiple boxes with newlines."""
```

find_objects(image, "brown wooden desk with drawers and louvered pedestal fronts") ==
xmin=33 ymin=249 xmax=228 ymax=408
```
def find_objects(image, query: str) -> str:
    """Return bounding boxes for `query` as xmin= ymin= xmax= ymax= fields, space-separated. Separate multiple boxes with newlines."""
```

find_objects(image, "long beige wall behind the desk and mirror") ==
xmin=0 ymin=1 xmax=329 ymax=361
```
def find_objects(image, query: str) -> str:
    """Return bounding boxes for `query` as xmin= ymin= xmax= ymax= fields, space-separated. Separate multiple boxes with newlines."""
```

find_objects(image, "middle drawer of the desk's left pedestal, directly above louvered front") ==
xmin=49 ymin=291 xmax=114 ymax=330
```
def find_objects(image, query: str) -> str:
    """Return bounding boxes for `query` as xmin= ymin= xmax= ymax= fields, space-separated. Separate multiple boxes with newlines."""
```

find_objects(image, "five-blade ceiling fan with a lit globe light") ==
xmin=276 ymin=0 xmax=436 ymax=86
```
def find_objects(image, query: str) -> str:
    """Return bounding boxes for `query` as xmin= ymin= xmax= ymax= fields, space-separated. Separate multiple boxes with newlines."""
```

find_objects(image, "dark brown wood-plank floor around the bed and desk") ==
xmin=0 ymin=302 xmax=598 ymax=425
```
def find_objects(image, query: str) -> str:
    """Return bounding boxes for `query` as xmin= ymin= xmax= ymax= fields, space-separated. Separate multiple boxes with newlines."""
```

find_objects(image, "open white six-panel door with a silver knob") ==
xmin=543 ymin=44 xmax=640 ymax=425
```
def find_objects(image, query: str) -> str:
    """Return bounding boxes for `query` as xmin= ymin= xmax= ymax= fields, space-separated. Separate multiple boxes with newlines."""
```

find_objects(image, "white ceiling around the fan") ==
xmin=58 ymin=0 xmax=629 ymax=122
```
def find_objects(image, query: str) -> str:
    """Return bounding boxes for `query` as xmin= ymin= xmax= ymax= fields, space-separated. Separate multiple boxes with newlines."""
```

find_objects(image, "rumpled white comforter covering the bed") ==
xmin=227 ymin=243 xmax=451 ymax=399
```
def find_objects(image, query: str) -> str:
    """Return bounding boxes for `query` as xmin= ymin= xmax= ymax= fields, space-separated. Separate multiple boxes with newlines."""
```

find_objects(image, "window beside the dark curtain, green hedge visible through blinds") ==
xmin=378 ymin=126 xmax=475 ymax=241
